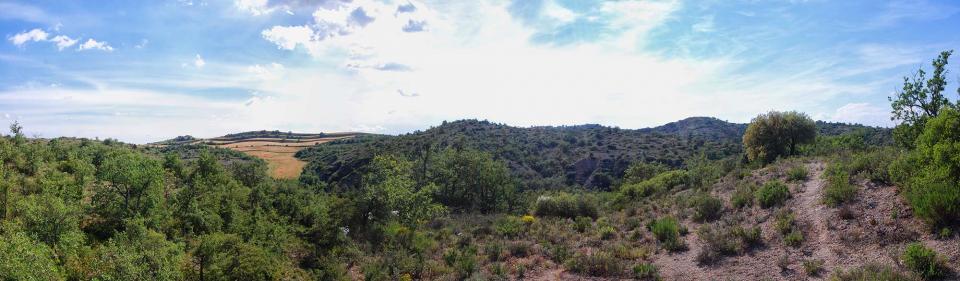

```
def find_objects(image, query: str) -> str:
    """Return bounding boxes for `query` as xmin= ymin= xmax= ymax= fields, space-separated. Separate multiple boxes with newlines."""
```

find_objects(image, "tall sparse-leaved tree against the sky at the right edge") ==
xmin=887 ymin=50 xmax=960 ymax=148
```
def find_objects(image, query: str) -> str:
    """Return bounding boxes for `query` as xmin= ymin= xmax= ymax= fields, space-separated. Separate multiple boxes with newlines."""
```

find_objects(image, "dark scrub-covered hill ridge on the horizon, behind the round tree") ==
xmin=296 ymin=117 xmax=890 ymax=190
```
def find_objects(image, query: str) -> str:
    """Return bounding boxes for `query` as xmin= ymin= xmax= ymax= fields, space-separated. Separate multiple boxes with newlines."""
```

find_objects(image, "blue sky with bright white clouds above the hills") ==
xmin=0 ymin=0 xmax=960 ymax=143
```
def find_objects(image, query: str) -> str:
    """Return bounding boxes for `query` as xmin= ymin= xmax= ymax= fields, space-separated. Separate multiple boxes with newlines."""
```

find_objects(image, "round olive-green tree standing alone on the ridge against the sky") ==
xmin=743 ymin=111 xmax=817 ymax=163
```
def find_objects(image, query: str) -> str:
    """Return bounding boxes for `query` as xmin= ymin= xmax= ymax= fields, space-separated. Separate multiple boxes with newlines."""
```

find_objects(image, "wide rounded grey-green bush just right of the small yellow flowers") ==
xmin=533 ymin=193 xmax=599 ymax=219
